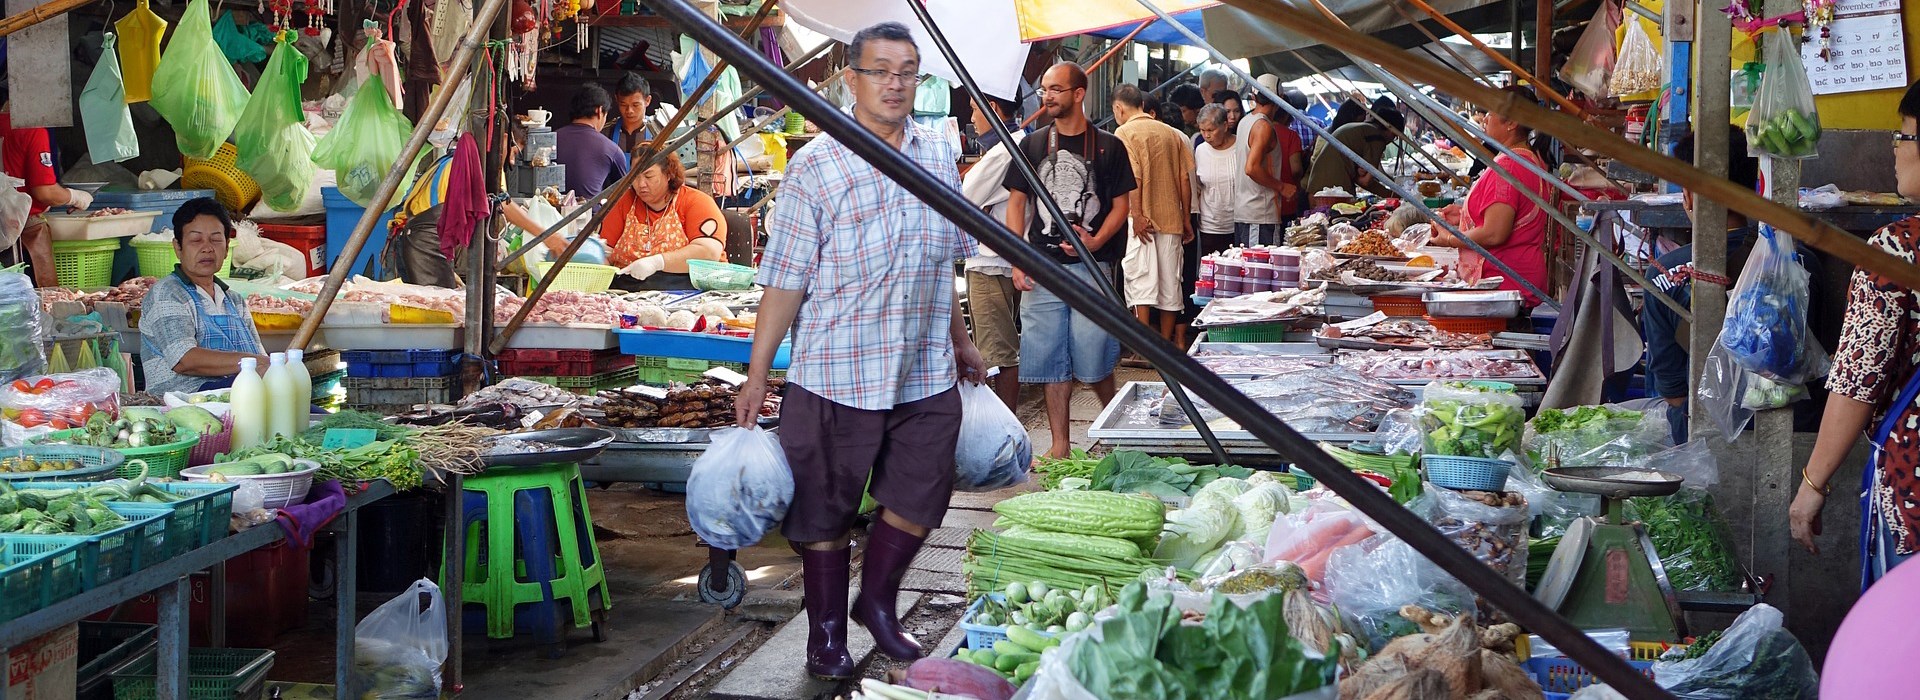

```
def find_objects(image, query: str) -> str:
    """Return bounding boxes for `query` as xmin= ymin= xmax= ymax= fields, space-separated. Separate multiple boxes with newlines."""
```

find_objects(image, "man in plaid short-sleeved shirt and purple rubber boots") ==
xmin=733 ymin=21 xmax=985 ymax=679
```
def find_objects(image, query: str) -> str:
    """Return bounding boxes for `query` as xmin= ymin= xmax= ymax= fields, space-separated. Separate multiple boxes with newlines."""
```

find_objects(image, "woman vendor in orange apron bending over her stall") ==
xmin=601 ymin=148 xmax=726 ymax=292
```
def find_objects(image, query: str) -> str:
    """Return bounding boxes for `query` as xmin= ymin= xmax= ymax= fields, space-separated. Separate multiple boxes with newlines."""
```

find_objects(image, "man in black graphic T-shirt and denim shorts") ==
xmin=1004 ymin=63 xmax=1137 ymax=458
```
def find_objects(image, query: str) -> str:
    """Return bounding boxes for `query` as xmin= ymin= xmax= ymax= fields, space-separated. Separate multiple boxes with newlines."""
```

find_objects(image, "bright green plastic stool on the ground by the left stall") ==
xmin=440 ymin=462 xmax=612 ymax=652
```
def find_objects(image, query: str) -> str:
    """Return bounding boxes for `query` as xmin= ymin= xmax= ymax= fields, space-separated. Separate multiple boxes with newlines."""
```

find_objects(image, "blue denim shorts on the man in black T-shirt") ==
xmin=1020 ymin=263 xmax=1119 ymax=384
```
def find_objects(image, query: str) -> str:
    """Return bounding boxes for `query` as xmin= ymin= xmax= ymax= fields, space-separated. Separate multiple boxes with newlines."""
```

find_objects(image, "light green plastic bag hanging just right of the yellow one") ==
xmin=150 ymin=0 xmax=248 ymax=161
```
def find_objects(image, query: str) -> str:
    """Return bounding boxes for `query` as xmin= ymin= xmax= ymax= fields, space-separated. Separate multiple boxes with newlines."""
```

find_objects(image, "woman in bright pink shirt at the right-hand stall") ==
xmin=1432 ymin=86 xmax=1553 ymax=309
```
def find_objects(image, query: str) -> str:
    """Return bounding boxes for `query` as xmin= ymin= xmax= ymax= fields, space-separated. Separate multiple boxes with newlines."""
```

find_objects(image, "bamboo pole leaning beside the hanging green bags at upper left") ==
xmin=286 ymin=0 xmax=507 ymax=349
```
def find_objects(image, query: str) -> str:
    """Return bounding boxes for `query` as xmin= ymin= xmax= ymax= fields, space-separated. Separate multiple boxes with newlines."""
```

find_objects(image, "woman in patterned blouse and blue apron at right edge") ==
xmin=1788 ymin=82 xmax=1920 ymax=589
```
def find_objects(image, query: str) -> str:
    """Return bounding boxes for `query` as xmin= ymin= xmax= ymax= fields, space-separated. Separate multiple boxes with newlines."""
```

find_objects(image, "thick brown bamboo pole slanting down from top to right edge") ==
xmin=1223 ymin=0 xmax=1920 ymax=290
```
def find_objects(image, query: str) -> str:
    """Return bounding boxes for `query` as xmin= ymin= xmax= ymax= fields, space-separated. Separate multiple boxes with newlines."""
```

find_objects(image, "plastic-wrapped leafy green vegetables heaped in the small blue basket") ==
xmin=1421 ymin=382 xmax=1526 ymax=458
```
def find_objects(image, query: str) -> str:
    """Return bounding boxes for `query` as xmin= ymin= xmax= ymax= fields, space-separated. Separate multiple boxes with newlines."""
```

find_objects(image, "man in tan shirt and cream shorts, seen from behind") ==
xmin=1114 ymin=84 xmax=1194 ymax=341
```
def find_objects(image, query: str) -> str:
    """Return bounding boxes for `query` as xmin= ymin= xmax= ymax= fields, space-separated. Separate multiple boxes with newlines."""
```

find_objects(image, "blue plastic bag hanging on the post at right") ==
xmin=1720 ymin=224 xmax=1830 ymax=384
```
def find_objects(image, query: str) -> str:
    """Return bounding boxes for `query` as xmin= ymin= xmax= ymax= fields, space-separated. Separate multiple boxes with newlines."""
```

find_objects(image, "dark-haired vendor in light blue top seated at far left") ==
xmin=140 ymin=198 xmax=267 ymax=395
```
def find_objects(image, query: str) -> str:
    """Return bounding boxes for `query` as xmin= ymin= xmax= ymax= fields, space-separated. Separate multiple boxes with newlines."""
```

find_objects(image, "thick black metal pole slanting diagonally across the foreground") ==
xmin=651 ymin=0 xmax=1667 ymax=698
